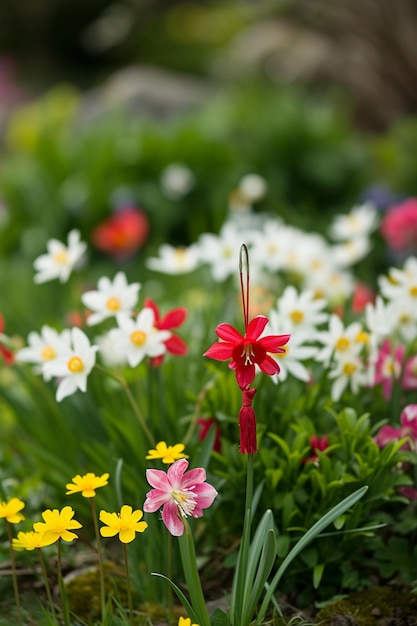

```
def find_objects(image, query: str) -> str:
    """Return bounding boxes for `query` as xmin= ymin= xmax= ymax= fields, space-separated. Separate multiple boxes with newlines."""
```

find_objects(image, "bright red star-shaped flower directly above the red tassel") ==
xmin=204 ymin=315 xmax=290 ymax=390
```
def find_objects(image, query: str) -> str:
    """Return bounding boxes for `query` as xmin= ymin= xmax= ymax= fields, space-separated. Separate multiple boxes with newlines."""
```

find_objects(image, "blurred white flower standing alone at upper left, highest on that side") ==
xmin=33 ymin=230 xmax=87 ymax=284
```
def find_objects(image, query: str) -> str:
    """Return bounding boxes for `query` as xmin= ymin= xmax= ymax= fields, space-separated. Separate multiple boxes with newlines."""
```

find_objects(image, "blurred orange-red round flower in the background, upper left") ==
xmin=91 ymin=207 xmax=149 ymax=257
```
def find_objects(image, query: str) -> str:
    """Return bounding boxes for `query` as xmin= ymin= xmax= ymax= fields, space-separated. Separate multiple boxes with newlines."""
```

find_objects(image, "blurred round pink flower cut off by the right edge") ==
xmin=381 ymin=198 xmax=417 ymax=252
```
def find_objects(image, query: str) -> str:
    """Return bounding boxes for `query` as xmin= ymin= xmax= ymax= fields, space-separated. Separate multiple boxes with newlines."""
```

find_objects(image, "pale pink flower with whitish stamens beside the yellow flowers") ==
xmin=143 ymin=459 xmax=217 ymax=537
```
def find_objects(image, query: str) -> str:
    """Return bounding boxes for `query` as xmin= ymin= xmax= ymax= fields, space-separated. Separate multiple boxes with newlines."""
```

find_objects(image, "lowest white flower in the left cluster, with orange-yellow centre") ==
xmin=43 ymin=328 xmax=98 ymax=402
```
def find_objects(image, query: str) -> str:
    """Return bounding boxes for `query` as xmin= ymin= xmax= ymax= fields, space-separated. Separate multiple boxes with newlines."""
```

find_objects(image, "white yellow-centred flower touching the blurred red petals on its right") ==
xmin=109 ymin=307 xmax=171 ymax=367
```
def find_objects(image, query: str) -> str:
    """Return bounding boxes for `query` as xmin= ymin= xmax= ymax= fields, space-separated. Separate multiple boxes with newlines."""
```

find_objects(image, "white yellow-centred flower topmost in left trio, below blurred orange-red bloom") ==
xmin=81 ymin=272 xmax=140 ymax=326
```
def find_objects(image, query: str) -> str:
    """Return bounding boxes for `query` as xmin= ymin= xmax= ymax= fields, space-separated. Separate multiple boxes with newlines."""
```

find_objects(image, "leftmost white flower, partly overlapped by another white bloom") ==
xmin=15 ymin=325 xmax=71 ymax=381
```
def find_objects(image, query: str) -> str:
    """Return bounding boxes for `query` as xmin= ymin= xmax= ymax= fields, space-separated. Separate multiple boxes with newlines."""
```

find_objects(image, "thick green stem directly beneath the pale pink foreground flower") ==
xmin=178 ymin=517 xmax=210 ymax=626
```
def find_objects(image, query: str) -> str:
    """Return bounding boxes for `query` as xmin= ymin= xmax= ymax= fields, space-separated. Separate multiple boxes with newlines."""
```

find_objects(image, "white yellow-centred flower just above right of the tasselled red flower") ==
xmin=270 ymin=285 xmax=329 ymax=334
